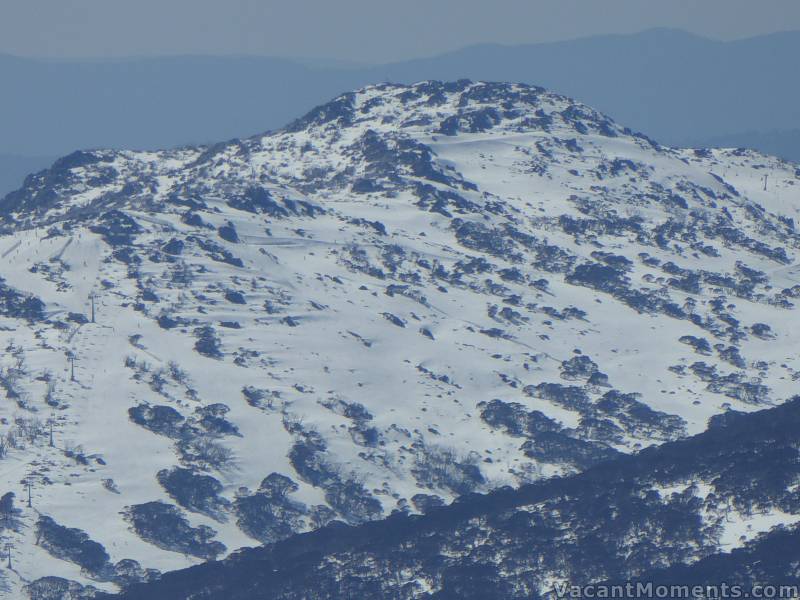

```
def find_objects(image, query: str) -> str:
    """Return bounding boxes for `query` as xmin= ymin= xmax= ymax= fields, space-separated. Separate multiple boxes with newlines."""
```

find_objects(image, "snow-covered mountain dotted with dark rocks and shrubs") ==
xmin=0 ymin=81 xmax=800 ymax=597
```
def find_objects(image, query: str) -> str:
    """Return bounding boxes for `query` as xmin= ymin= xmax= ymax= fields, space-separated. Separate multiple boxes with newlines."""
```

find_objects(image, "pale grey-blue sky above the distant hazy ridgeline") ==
xmin=0 ymin=0 xmax=800 ymax=62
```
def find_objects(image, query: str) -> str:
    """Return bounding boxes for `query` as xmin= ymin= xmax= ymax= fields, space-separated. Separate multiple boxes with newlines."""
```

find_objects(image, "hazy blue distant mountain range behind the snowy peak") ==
xmin=0 ymin=29 xmax=800 ymax=191
